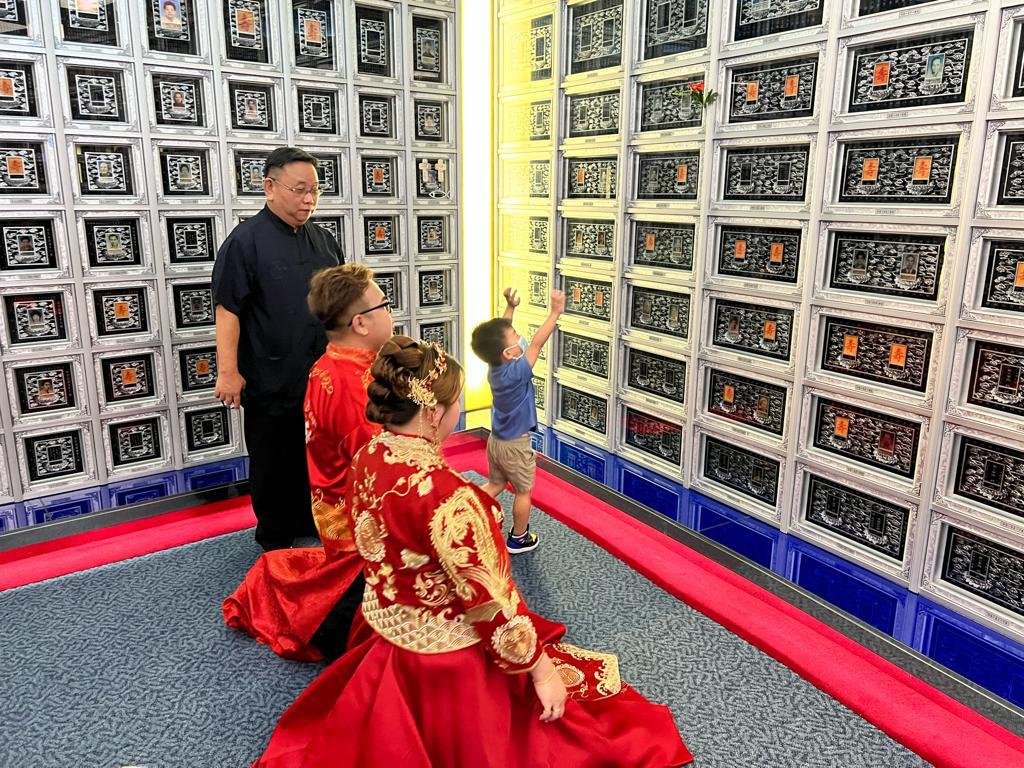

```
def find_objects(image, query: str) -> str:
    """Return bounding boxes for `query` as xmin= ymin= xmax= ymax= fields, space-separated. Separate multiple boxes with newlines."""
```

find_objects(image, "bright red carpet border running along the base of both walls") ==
xmin=0 ymin=435 xmax=1024 ymax=768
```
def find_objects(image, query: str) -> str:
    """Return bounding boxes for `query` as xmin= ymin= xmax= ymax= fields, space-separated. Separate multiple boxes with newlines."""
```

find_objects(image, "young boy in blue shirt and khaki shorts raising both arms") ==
xmin=470 ymin=288 xmax=565 ymax=554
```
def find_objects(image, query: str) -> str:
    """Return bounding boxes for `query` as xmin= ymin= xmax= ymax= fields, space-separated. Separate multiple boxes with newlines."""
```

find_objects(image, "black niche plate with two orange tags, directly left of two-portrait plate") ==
xmin=717 ymin=226 xmax=803 ymax=284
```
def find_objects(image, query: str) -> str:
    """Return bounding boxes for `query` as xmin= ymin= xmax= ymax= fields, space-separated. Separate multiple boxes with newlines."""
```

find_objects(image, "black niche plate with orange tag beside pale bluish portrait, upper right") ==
xmin=847 ymin=29 xmax=974 ymax=113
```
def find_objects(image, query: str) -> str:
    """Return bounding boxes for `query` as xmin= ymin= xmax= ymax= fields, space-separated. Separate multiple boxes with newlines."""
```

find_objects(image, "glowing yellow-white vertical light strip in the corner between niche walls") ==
xmin=459 ymin=0 xmax=497 ymax=411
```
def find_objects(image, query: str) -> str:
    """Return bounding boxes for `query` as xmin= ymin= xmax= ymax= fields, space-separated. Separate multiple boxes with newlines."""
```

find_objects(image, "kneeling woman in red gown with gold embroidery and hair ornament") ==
xmin=255 ymin=336 xmax=692 ymax=768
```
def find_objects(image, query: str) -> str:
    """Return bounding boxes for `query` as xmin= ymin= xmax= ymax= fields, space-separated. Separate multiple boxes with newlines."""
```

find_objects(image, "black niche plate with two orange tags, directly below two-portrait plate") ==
xmin=821 ymin=317 xmax=932 ymax=392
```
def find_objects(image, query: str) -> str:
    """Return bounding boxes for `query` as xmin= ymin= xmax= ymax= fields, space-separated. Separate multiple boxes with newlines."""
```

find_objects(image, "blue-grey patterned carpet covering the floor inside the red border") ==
xmin=0 ymin=489 xmax=927 ymax=768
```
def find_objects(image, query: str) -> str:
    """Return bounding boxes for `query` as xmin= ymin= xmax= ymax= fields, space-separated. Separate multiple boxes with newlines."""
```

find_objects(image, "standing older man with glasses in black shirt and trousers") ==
xmin=213 ymin=146 xmax=344 ymax=550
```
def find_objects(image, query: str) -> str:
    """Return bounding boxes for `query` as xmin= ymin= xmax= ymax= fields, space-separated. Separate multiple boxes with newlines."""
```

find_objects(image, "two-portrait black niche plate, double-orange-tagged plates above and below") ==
xmin=828 ymin=230 xmax=946 ymax=301
